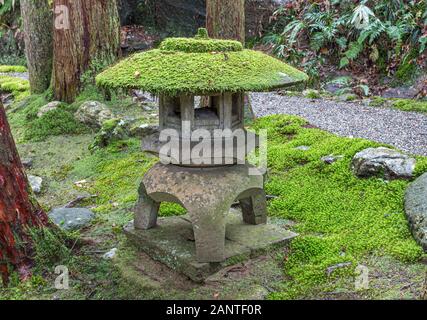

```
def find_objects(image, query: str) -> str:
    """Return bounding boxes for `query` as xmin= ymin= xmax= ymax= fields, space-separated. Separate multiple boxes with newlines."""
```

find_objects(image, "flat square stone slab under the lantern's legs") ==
xmin=124 ymin=210 xmax=297 ymax=282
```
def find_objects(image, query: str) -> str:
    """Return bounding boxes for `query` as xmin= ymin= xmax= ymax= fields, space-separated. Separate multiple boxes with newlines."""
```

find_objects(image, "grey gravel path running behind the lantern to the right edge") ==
xmin=251 ymin=93 xmax=427 ymax=156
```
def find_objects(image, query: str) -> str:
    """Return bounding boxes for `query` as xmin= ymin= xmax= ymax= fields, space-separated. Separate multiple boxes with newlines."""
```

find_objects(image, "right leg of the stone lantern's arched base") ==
xmin=239 ymin=189 xmax=267 ymax=225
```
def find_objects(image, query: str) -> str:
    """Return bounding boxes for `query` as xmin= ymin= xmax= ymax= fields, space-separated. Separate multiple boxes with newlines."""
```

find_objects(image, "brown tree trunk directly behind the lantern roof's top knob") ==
xmin=206 ymin=0 xmax=245 ymax=43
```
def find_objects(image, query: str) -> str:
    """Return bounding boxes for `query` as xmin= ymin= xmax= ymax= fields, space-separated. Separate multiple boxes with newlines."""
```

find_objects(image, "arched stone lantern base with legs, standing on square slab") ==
xmin=134 ymin=163 xmax=267 ymax=263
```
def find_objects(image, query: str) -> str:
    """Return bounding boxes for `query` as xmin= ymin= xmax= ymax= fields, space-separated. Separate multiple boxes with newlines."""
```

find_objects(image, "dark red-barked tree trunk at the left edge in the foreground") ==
xmin=0 ymin=102 xmax=48 ymax=284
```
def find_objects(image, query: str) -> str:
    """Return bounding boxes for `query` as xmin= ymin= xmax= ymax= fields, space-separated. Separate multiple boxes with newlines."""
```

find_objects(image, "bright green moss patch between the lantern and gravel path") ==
xmin=255 ymin=116 xmax=427 ymax=299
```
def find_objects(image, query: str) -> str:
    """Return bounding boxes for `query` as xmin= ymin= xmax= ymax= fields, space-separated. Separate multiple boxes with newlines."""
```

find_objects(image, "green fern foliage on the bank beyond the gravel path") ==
xmin=264 ymin=0 xmax=427 ymax=84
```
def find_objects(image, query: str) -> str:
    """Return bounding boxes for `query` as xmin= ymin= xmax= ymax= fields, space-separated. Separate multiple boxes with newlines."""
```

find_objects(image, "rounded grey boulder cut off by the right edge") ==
xmin=405 ymin=173 xmax=427 ymax=252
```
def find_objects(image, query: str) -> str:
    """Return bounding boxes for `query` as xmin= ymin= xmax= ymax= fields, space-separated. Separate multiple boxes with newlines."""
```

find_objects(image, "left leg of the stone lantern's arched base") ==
xmin=134 ymin=182 xmax=160 ymax=230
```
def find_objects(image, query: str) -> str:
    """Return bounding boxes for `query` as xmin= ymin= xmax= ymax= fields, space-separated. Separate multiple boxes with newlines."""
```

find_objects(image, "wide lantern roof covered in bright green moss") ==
xmin=96 ymin=29 xmax=308 ymax=95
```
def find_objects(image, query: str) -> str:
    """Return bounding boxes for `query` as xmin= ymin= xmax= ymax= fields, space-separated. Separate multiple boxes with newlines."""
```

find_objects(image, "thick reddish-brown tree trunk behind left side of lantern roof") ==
xmin=52 ymin=0 xmax=120 ymax=103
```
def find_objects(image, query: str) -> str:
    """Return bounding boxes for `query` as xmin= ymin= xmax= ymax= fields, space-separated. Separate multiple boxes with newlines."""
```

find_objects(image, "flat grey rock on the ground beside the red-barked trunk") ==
xmin=49 ymin=208 xmax=95 ymax=231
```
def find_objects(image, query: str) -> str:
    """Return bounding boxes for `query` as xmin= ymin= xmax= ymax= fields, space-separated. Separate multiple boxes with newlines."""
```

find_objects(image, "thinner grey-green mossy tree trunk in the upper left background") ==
xmin=20 ymin=0 xmax=53 ymax=93
